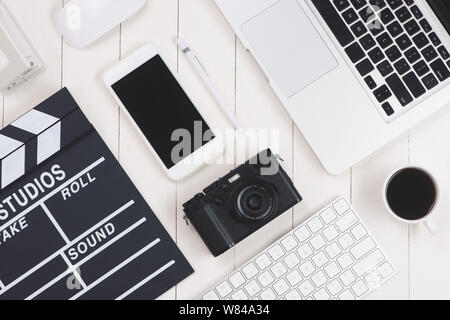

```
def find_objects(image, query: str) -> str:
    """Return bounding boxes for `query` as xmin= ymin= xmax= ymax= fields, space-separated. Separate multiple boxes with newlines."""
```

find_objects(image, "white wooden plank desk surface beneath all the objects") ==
xmin=0 ymin=0 xmax=450 ymax=299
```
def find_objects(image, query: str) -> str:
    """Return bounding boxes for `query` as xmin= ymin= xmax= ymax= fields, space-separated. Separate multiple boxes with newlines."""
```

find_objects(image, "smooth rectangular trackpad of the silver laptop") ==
xmin=241 ymin=0 xmax=338 ymax=97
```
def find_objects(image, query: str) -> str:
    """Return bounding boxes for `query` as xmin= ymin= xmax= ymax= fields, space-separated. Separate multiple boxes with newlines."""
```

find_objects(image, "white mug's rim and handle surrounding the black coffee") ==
xmin=383 ymin=165 xmax=440 ymax=235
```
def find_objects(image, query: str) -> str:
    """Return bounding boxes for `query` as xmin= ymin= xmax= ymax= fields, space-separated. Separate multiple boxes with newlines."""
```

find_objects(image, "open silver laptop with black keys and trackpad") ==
xmin=215 ymin=0 xmax=450 ymax=175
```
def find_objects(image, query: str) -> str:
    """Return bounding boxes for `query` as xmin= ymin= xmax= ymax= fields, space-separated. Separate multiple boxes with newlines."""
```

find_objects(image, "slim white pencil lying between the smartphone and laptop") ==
xmin=177 ymin=38 xmax=242 ymax=130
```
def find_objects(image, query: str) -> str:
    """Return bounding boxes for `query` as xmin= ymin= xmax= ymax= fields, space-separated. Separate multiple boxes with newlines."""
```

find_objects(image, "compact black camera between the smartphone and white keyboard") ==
xmin=183 ymin=149 xmax=302 ymax=257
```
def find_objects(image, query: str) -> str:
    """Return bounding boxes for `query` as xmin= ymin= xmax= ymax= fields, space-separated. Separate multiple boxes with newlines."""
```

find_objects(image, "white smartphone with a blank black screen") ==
xmin=104 ymin=45 xmax=223 ymax=181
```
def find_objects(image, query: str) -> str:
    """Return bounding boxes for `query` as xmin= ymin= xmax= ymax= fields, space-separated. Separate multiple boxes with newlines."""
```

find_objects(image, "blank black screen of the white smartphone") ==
xmin=112 ymin=55 xmax=214 ymax=169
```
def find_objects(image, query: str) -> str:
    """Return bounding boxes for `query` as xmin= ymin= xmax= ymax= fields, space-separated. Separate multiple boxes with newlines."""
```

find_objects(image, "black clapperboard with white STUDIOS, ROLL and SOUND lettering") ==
xmin=0 ymin=89 xmax=193 ymax=300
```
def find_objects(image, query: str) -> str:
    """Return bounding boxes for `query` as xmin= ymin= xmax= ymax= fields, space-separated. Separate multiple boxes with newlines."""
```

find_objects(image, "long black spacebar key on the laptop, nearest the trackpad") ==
xmin=312 ymin=0 xmax=355 ymax=47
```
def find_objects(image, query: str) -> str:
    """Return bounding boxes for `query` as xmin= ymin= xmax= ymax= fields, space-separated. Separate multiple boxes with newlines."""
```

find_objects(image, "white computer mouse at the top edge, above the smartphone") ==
xmin=57 ymin=0 xmax=145 ymax=48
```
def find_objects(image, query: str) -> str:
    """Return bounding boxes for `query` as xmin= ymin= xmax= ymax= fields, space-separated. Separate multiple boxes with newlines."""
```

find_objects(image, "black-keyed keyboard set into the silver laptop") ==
xmin=312 ymin=0 xmax=450 ymax=120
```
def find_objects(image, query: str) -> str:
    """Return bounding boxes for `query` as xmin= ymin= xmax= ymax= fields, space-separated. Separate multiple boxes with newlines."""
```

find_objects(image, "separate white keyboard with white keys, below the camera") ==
xmin=201 ymin=197 xmax=395 ymax=300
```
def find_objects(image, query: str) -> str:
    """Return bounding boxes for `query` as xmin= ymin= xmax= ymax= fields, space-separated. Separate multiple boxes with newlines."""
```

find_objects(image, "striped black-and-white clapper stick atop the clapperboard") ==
xmin=0 ymin=89 xmax=91 ymax=189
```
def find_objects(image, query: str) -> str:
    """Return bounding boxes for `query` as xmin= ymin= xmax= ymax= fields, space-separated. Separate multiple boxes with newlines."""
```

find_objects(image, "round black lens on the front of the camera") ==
xmin=236 ymin=185 xmax=275 ymax=220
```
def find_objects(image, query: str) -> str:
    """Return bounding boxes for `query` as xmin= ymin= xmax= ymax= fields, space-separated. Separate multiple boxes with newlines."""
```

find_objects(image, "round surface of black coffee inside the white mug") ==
xmin=386 ymin=168 xmax=436 ymax=220
